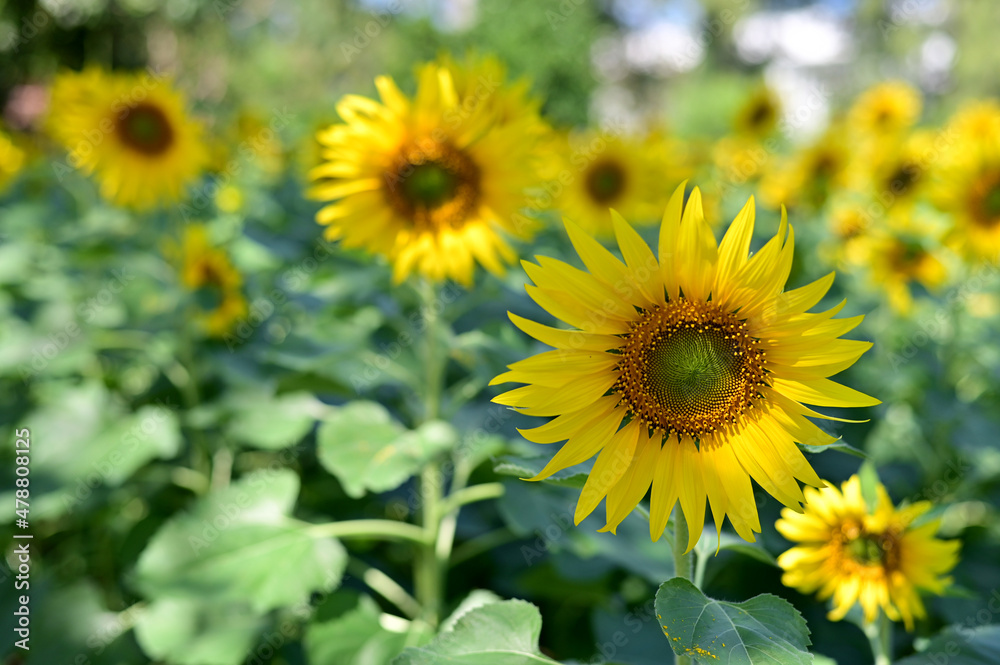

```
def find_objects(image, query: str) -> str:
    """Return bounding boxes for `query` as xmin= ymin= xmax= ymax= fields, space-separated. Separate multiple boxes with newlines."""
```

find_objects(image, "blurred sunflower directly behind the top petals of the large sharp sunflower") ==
xmin=553 ymin=130 xmax=679 ymax=236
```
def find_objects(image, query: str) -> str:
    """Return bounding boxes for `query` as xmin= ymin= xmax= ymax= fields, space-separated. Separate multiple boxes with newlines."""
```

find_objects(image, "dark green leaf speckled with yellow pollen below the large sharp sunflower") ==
xmin=655 ymin=577 xmax=812 ymax=665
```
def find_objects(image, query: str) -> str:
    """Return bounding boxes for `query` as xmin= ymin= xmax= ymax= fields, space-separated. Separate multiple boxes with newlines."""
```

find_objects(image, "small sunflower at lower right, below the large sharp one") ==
xmin=775 ymin=476 xmax=960 ymax=630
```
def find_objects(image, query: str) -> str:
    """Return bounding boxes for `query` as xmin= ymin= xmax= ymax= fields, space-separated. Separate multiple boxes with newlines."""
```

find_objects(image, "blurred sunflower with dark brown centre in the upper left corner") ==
xmin=48 ymin=68 xmax=208 ymax=209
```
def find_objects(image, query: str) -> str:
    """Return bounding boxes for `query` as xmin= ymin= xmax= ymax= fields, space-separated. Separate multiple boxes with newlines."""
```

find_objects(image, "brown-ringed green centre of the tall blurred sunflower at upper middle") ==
xmin=384 ymin=141 xmax=481 ymax=229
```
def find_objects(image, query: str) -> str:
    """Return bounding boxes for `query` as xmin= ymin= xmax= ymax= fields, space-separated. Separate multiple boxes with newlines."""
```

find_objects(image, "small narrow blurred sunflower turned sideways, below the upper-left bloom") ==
xmin=168 ymin=225 xmax=248 ymax=337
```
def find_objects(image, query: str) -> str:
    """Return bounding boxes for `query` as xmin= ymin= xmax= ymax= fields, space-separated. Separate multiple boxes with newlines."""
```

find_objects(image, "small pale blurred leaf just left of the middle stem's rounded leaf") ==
xmin=228 ymin=392 xmax=327 ymax=450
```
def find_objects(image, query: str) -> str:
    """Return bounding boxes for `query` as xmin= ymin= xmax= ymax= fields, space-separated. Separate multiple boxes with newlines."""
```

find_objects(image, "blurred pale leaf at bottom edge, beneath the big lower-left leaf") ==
xmin=135 ymin=598 xmax=263 ymax=665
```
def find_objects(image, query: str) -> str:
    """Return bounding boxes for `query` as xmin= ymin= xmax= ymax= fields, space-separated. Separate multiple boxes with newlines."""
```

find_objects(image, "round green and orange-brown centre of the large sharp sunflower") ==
xmin=613 ymin=298 xmax=767 ymax=438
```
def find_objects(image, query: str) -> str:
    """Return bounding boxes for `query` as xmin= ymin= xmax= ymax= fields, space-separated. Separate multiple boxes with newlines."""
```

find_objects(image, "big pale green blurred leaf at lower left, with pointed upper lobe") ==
xmin=136 ymin=471 xmax=347 ymax=612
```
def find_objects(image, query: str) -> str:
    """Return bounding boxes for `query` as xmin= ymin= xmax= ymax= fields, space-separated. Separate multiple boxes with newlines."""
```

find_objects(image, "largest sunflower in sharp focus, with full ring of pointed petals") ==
xmin=493 ymin=185 xmax=878 ymax=549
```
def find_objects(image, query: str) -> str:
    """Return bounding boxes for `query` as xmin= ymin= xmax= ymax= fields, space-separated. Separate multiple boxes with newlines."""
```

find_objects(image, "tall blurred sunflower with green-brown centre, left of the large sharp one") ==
xmin=310 ymin=57 xmax=537 ymax=285
